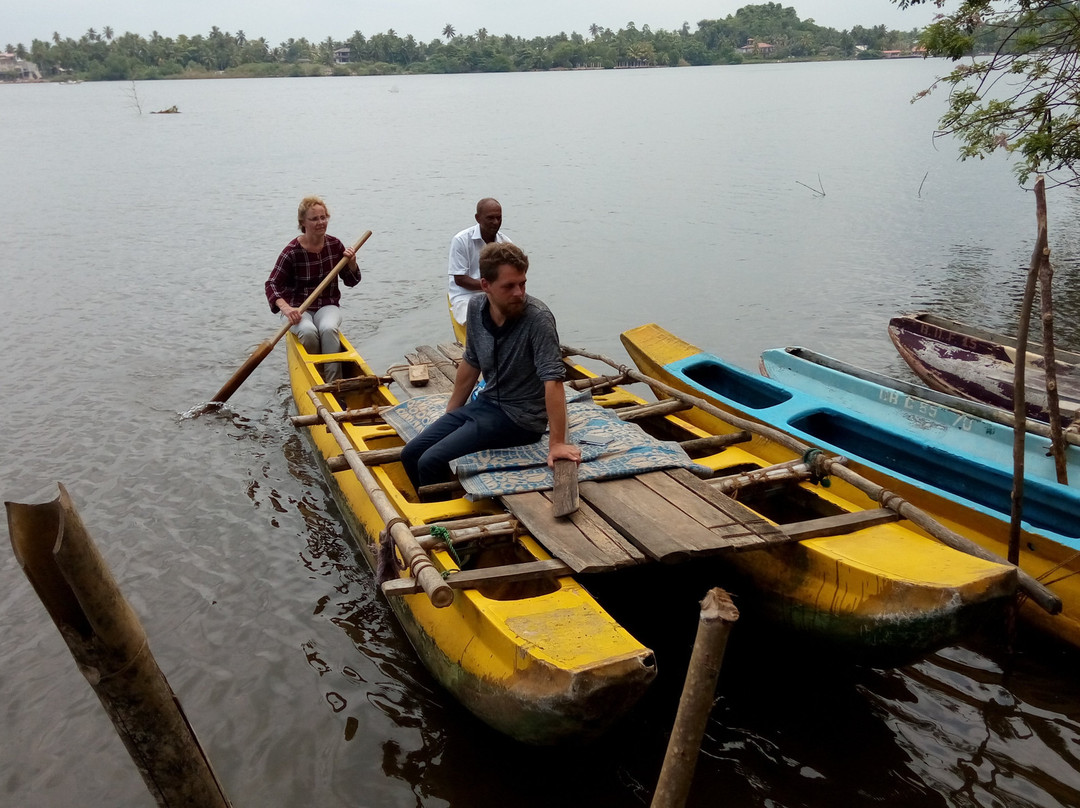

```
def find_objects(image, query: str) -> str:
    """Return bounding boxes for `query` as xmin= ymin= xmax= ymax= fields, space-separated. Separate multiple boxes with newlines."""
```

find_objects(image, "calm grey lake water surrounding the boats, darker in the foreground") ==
xmin=0 ymin=60 xmax=1080 ymax=808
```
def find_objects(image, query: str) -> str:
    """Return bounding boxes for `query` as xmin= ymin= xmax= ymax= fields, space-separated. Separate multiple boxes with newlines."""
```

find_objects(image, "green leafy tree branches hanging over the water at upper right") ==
xmin=894 ymin=0 xmax=1080 ymax=187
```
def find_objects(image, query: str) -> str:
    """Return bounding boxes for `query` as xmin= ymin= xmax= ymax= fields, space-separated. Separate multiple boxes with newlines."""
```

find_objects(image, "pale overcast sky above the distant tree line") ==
xmin=0 ymin=0 xmax=935 ymax=48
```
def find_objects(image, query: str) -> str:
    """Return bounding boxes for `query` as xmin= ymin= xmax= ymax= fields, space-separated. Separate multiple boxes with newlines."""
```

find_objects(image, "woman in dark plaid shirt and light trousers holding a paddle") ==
xmin=266 ymin=197 xmax=360 ymax=381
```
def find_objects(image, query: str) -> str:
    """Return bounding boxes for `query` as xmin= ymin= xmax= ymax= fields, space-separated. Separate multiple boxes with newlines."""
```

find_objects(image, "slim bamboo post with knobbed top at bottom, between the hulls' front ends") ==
xmin=651 ymin=589 xmax=739 ymax=808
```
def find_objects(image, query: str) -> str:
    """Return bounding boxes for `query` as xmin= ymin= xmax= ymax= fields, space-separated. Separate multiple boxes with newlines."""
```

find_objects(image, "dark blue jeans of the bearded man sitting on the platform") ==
xmin=402 ymin=396 xmax=543 ymax=488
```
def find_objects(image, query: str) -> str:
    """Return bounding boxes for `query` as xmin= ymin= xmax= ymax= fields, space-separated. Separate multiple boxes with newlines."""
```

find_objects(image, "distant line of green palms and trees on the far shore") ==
xmin=8 ymin=3 xmax=918 ymax=80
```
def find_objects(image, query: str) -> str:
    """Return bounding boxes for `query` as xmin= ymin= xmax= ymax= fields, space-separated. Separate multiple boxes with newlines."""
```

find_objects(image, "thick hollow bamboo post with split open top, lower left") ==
xmin=4 ymin=485 xmax=230 ymax=808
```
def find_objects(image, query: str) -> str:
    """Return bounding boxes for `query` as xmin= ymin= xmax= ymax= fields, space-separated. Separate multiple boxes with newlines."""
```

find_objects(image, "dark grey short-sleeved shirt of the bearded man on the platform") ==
xmin=464 ymin=295 xmax=566 ymax=432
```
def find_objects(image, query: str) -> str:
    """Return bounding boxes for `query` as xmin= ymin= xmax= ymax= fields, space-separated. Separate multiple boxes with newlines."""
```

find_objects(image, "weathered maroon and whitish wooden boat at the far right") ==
xmin=889 ymin=312 xmax=1080 ymax=423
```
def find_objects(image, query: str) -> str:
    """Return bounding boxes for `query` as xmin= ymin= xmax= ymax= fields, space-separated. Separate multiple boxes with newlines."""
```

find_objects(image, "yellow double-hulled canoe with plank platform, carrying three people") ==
xmin=287 ymin=335 xmax=1016 ymax=744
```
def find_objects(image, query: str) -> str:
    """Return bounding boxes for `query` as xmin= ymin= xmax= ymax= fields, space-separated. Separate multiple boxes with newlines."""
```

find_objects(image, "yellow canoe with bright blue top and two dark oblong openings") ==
xmin=621 ymin=324 xmax=1080 ymax=646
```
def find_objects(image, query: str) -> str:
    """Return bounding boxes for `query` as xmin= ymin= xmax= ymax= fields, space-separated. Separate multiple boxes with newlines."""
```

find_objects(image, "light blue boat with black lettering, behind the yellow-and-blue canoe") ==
xmin=761 ymin=347 xmax=1080 ymax=488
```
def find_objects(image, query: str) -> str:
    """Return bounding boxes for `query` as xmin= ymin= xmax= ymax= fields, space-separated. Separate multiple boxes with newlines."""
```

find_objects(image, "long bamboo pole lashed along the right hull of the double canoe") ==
xmin=562 ymin=346 xmax=1062 ymax=615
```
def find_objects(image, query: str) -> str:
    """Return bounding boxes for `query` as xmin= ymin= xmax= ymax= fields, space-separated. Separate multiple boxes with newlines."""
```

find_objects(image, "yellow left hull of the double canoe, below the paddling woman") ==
xmin=287 ymin=335 xmax=656 ymax=744
